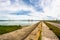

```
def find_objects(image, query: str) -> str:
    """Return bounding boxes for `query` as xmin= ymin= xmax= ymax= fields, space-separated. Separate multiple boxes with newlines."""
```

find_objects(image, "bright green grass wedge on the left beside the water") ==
xmin=0 ymin=25 xmax=22 ymax=35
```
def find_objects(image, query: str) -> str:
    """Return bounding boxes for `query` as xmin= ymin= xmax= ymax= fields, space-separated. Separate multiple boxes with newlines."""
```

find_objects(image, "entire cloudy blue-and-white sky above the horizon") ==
xmin=0 ymin=0 xmax=60 ymax=20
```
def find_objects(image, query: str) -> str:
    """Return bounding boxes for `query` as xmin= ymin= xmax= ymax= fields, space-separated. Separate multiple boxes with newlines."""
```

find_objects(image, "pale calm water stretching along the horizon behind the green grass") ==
xmin=0 ymin=20 xmax=39 ymax=26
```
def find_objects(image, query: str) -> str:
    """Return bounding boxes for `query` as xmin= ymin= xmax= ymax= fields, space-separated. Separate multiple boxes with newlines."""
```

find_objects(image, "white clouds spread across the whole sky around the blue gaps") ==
xmin=0 ymin=0 xmax=60 ymax=20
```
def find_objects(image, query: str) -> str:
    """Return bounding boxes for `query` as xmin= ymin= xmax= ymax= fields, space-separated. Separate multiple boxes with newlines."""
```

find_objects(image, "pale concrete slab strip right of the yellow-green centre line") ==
xmin=42 ymin=22 xmax=59 ymax=40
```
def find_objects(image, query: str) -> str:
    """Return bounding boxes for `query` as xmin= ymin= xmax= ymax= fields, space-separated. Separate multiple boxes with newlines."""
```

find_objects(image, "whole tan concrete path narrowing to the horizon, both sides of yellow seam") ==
xmin=0 ymin=22 xmax=59 ymax=40
